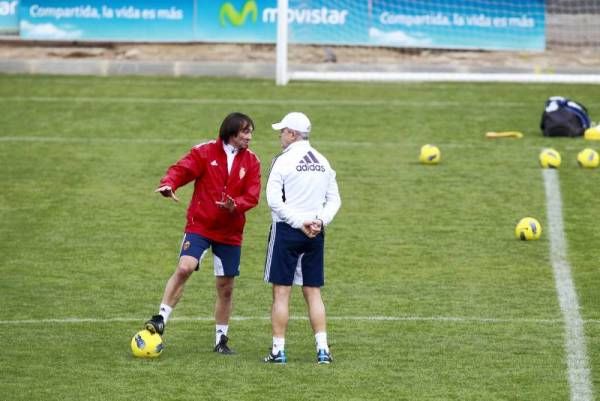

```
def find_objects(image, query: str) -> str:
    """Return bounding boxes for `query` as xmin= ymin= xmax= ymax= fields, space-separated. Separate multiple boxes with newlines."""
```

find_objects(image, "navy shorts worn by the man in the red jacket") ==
xmin=179 ymin=233 xmax=242 ymax=277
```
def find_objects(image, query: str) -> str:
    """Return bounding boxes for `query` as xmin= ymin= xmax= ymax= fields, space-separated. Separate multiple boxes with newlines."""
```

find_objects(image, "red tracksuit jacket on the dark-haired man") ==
xmin=160 ymin=139 xmax=260 ymax=245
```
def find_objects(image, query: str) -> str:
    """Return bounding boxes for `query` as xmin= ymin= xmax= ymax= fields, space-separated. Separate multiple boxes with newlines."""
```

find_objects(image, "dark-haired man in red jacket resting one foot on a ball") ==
xmin=145 ymin=113 xmax=260 ymax=354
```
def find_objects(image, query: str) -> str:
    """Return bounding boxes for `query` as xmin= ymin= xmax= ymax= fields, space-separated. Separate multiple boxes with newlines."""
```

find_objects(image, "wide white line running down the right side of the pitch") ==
xmin=542 ymin=169 xmax=593 ymax=401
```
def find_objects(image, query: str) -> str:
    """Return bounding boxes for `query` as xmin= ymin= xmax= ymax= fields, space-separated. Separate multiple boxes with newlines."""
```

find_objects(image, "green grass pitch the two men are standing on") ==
xmin=0 ymin=75 xmax=600 ymax=401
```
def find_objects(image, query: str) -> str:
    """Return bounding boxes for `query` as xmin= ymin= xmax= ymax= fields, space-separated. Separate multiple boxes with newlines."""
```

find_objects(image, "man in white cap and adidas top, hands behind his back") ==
xmin=265 ymin=112 xmax=341 ymax=364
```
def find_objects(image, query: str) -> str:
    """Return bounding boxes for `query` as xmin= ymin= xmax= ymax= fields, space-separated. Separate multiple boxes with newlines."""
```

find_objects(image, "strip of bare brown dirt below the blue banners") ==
xmin=0 ymin=40 xmax=600 ymax=73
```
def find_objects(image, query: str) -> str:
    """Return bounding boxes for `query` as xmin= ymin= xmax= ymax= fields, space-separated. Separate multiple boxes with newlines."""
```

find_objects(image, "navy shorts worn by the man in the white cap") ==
xmin=265 ymin=222 xmax=325 ymax=287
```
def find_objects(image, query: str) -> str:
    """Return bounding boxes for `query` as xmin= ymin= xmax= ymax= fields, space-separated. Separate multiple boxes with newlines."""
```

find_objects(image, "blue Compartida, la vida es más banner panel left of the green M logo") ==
xmin=19 ymin=0 xmax=195 ymax=42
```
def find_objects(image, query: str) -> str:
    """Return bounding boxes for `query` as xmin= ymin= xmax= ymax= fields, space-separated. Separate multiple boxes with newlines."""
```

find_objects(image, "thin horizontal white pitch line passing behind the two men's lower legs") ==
xmin=0 ymin=316 xmax=600 ymax=326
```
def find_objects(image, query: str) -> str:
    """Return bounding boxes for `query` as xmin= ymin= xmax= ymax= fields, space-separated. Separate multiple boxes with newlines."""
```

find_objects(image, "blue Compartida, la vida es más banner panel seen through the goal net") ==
xmin=369 ymin=0 xmax=546 ymax=50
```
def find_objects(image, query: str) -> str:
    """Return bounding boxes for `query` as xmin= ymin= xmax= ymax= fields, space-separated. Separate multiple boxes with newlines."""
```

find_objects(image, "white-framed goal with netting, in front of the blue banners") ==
xmin=277 ymin=0 xmax=600 ymax=85
